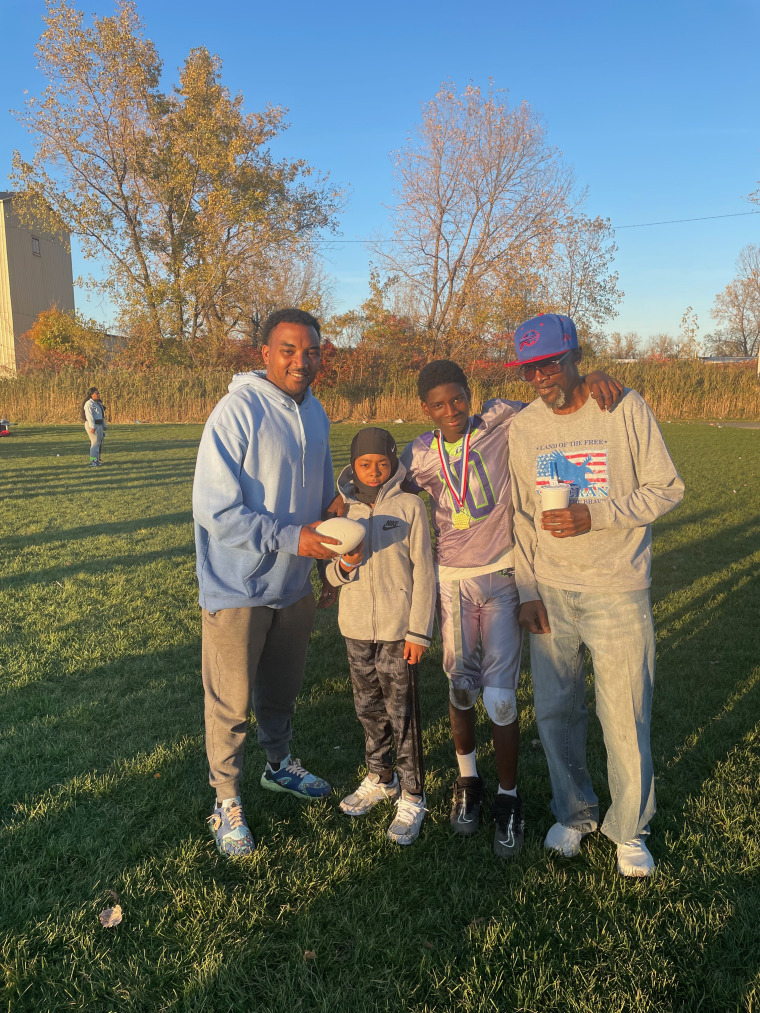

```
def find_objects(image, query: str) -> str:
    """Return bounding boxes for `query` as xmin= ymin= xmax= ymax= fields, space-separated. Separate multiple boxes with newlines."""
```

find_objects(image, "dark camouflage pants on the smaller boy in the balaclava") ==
xmin=346 ymin=637 xmax=425 ymax=795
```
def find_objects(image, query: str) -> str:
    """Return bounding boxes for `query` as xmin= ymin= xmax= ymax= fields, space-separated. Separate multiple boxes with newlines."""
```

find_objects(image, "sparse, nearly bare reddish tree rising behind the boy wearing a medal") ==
xmin=373 ymin=83 xmax=573 ymax=357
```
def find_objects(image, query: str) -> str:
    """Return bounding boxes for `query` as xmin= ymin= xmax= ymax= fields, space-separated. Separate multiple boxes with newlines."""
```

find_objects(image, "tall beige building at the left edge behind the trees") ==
xmin=0 ymin=190 xmax=74 ymax=373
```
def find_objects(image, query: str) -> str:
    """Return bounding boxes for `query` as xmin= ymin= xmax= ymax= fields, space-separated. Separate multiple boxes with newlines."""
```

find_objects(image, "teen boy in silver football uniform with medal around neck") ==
xmin=401 ymin=359 xmax=622 ymax=858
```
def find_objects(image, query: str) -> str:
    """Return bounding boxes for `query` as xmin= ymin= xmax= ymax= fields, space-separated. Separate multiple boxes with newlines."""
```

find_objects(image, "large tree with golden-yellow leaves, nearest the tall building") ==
xmin=12 ymin=0 xmax=340 ymax=342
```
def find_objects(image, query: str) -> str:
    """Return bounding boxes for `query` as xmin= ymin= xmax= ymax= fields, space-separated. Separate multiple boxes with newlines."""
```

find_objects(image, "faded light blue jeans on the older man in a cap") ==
xmin=530 ymin=583 xmax=656 ymax=844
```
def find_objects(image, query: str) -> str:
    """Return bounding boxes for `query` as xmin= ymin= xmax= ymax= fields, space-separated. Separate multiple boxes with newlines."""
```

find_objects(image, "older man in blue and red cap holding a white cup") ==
xmin=510 ymin=313 xmax=684 ymax=876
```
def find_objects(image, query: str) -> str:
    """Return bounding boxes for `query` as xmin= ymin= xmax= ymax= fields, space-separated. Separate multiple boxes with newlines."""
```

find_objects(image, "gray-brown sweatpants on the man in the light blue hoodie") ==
xmin=203 ymin=592 xmax=315 ymax=801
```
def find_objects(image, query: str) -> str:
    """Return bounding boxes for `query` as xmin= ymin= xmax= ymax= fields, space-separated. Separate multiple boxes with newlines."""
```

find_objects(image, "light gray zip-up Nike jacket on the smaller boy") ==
xmin=326 ymin=463 xmax=436 ymax=647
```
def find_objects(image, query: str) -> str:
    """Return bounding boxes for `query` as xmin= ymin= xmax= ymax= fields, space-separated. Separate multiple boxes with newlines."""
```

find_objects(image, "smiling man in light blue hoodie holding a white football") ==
xmin=193 ymin=309 xmax=342 ymax=856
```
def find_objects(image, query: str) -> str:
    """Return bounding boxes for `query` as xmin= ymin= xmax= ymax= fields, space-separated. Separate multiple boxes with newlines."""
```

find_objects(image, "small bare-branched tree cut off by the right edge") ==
xmin=710 ymin=243 xmax=760 ymax=356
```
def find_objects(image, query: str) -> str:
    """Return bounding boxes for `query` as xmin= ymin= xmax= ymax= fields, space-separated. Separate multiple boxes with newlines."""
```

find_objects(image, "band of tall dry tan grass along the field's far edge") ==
xmin=0 ymin=361 xmax=760 ymax=424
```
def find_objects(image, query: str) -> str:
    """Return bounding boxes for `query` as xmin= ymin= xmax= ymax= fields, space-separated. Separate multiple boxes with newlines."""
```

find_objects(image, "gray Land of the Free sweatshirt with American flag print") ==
xmin=510 ymin=388 xmax=684 ymax=602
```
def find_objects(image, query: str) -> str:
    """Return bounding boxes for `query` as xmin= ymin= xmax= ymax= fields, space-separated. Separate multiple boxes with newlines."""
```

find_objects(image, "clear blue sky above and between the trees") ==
xmin=0 ymin=0 xmax=760 ymax=337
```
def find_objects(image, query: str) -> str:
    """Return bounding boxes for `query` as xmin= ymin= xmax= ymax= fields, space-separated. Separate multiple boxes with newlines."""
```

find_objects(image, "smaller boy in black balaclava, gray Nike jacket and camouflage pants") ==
xmin=326 ymin=427 xmax=436 ymax=845
